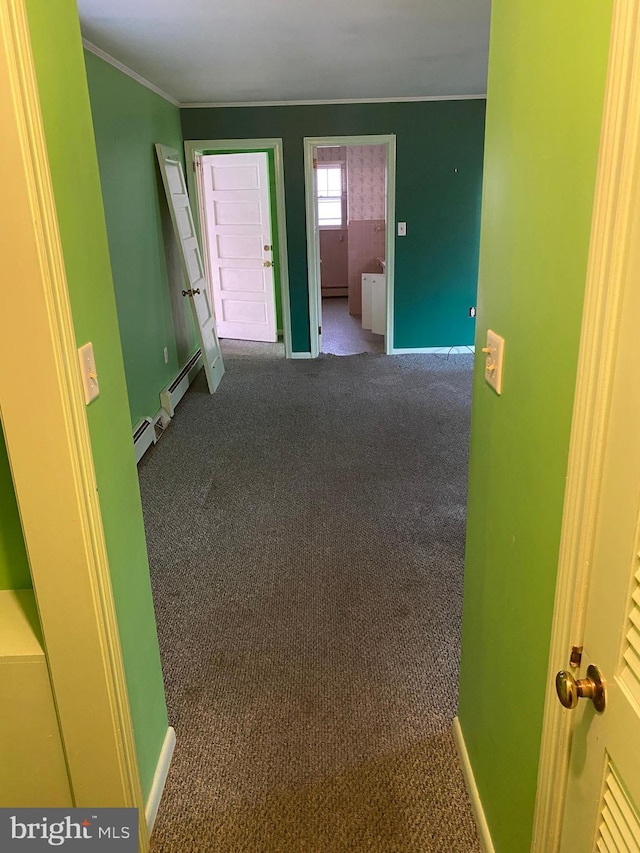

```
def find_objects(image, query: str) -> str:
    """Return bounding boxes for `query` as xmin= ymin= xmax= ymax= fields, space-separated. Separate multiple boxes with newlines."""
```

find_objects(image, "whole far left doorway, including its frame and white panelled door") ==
xmin=185 ymin=139 xmax=292 ymax=358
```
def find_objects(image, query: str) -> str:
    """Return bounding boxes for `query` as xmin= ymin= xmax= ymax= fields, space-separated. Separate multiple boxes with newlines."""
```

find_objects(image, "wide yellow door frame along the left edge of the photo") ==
xmin=0 ymin=0 xmax=149 ymax=853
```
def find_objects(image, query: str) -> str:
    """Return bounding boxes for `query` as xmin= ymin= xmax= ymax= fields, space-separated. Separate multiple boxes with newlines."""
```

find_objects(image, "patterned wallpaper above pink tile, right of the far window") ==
xmin=347 ymin=145 xmax=386 ymax=222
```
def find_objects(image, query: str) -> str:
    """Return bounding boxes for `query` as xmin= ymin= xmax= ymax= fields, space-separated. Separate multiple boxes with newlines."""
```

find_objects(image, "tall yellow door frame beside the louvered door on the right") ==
xmin=531 ymin=0 xmax=640 ymax=853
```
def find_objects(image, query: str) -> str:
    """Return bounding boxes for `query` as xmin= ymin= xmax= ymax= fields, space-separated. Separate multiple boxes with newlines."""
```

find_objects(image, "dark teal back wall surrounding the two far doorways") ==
xmin=181 ymin=100 xmax=485 ymax=352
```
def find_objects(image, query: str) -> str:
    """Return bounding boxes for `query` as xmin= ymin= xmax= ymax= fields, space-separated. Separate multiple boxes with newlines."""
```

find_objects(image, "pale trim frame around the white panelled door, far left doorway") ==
xmin=184 ymin=138 xmax=293 ymax=358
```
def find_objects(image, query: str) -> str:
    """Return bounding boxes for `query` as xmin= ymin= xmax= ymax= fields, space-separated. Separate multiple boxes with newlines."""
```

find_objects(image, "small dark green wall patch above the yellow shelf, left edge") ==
xmin=0 ymin=424 xmax=32 ymax=589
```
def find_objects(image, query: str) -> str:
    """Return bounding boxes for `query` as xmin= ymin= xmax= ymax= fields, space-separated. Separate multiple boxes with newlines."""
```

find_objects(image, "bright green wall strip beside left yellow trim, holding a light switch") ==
xmin=27 ymin=0 xmax=168 ymax=794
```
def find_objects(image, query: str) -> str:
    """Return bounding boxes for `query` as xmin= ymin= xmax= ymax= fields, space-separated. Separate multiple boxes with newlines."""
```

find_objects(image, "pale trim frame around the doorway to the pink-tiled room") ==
xmin=303 ymin=133 xmax=396 ymax=358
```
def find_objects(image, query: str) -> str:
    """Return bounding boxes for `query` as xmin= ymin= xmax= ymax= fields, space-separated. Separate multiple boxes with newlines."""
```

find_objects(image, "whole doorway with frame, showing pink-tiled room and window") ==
xmin=304 ymin=135 xmax=395 ymax=357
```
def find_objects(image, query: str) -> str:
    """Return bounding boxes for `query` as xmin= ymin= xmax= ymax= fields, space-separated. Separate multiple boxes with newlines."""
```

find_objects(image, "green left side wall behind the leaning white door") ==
xmin=85 ymin=51 xmax=197 ymax=425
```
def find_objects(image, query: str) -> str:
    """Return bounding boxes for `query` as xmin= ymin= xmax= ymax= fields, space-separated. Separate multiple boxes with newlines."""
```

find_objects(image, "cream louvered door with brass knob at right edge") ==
xmin=560 ymin=163 xmax=640 ymax=853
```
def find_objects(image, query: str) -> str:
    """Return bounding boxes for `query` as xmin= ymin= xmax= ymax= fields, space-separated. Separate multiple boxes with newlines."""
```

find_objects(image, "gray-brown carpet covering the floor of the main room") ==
xmin=139 ymin=355 xmax=480 ymax=853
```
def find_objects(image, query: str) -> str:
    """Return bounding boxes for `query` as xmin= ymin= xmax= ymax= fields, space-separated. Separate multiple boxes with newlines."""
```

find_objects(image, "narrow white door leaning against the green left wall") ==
xmin=156 ymin=143 xmax=224 ymax=394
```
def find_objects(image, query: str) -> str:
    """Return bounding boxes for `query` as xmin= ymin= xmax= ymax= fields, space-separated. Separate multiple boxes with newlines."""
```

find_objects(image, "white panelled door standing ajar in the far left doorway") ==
xmin=196 ymin=152 xmax=278 ymax=342
